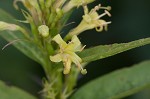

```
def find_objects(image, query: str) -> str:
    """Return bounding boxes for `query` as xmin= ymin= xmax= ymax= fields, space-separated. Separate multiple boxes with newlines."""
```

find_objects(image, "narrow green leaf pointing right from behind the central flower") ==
xmin=79 ymin=38 xmax=150 ymax=62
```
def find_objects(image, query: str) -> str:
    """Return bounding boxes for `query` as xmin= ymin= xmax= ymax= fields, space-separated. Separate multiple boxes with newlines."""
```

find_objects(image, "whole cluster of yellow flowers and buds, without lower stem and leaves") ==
xmin=0 ymin=0 xmax=111 ymax=74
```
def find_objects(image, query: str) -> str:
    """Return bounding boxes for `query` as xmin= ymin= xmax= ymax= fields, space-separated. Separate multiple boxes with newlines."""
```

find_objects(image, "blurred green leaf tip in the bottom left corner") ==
xmin=0 ymin=81 xmax=37 ymax=99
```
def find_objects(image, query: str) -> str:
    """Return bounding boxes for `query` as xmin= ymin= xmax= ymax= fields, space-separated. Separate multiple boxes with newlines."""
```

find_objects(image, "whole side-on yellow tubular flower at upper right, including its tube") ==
xmin=67 ymin=4 xmax=111 ymax=38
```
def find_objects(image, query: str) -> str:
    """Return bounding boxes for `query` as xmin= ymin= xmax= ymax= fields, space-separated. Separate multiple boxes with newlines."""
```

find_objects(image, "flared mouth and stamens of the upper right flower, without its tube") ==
xmin=81 ymin=5 xmax=111 ymax=32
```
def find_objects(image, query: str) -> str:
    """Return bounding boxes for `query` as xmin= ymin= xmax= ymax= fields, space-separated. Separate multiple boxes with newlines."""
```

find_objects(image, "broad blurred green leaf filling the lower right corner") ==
xmin=71 ymin=61 xmax=150 ymax=99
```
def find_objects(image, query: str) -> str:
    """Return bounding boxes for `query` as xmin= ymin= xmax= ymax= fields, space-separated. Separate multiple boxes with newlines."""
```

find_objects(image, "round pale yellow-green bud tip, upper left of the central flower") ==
xmin=38 ymin=25 xmax=49 ymax=37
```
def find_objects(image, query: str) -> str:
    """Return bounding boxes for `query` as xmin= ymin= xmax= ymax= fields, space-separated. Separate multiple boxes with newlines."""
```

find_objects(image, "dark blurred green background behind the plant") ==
xmin=0 ymin=0 xmax=150 ymax=99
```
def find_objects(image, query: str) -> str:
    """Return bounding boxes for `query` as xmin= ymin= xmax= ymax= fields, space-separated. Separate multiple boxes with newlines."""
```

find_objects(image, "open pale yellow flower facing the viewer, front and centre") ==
xmin=50 ymin=34 xmax=87 ymax=74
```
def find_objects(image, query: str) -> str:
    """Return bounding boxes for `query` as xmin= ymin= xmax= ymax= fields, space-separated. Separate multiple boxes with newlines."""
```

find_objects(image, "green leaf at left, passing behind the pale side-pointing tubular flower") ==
xmin=0 ymin=9 xmax=45 ymax=64
